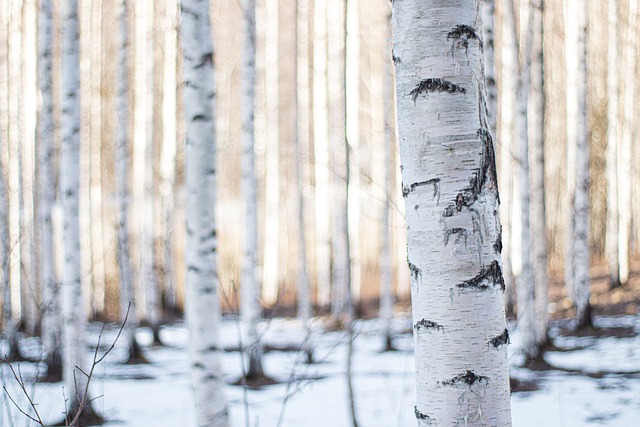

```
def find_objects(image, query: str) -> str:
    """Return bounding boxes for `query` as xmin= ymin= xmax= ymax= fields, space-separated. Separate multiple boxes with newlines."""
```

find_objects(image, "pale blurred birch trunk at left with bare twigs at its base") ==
xmin=60 ymin=0 xmax=88 ymax=408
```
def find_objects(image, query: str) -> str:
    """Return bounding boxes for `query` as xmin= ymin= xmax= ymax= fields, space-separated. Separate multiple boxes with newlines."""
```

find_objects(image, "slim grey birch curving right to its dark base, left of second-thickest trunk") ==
xmin=116 ymin=0 xmax=142 ymax=362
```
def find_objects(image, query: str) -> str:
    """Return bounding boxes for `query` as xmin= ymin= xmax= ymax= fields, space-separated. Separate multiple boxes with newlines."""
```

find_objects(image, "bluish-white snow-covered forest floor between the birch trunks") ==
xmin=0 ymin=317 xmax=640 ymax=427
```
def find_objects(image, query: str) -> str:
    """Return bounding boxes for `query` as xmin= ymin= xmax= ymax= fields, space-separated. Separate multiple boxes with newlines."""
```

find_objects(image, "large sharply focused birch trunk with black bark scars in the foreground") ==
xmin=393 ymin=0 xmax=511 ymax=426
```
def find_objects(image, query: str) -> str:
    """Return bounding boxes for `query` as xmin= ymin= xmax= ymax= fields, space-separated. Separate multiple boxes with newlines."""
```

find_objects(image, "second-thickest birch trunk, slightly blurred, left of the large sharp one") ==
xmin=180 ymin=0 xmax=229 ymax=427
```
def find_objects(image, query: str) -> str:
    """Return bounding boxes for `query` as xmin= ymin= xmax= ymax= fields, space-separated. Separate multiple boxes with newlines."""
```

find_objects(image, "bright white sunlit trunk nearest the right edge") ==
xmin=618 ymin=1 xmax=638 ymax=285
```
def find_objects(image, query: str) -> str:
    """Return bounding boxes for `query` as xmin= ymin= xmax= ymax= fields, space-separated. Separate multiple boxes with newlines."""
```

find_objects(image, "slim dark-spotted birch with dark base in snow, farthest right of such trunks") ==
xmin=568 ymin=0 xmax=591 ymax=327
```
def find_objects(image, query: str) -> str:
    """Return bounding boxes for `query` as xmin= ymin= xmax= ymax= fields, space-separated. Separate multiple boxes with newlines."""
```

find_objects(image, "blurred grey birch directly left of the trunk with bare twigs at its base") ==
xmin=37 ymin=0 xmax=62 ymax=379
